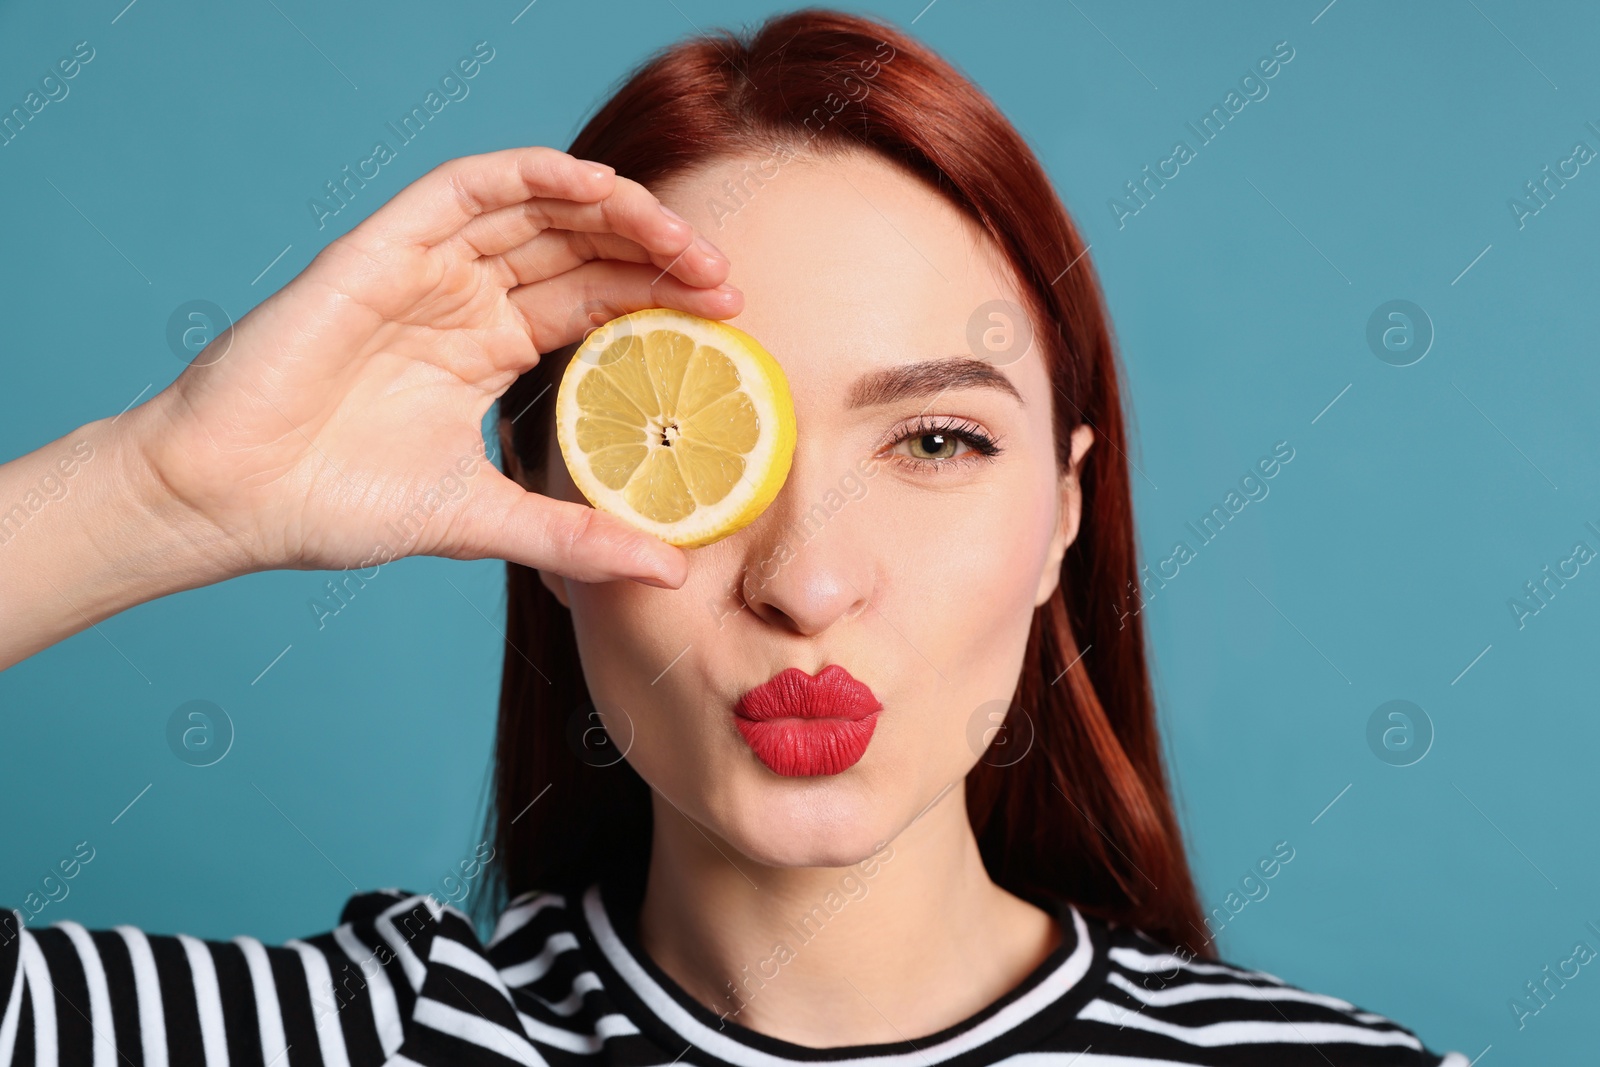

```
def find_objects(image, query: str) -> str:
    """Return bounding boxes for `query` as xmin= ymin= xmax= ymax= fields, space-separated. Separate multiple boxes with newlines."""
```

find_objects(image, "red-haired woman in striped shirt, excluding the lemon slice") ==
xmin=0 ymin=11 xmax=1466 ymax=1067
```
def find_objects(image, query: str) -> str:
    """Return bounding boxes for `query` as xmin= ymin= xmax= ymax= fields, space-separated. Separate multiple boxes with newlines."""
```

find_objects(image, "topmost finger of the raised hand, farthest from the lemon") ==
xmin=352 ymin=146 xmax=618 ymax=246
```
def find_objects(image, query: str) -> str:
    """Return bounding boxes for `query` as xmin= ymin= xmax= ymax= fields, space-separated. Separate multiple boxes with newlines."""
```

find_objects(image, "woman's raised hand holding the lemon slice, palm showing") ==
xmin=130 ymin=147 xmax=744 ymax=587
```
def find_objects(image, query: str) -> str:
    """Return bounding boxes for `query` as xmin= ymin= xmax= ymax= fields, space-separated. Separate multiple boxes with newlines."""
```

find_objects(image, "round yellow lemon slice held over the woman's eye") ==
xmin=555 ymin=307 xmax=795 ymax=547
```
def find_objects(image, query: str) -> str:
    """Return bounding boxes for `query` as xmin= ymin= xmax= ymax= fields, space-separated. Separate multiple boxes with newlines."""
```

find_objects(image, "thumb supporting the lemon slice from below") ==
xmin=438 ymin=477 xmax=688 ymax=589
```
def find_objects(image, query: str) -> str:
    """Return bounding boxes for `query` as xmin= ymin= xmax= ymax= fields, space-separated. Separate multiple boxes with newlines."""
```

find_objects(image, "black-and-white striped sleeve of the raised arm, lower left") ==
xmin=0 ymin=889 xmax=486 ymax=1064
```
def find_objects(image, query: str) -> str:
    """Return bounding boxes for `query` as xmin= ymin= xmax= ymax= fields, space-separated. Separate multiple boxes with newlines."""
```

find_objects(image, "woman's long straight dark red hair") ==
xmin=475 ymin=8 xmax=1214 ymax=957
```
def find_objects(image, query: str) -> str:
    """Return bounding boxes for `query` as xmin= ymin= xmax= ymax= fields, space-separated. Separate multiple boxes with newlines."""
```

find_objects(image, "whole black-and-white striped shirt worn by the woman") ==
xmin=0 ymin=886 xmax=1469 ymax=1067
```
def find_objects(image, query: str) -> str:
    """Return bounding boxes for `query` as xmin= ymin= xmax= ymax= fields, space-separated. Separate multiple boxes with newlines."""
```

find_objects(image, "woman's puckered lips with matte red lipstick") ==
xmin=733 ymin=664 xmax=883 ymax=777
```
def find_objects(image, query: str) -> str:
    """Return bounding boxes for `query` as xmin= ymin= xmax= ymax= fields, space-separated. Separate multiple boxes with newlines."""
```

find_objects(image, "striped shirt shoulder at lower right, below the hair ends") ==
xmin=1078 ymin=920 xmax=1467 ymax=1067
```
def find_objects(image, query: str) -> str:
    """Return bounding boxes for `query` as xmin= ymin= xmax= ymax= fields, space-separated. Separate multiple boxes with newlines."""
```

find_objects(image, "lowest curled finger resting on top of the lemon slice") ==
xmin=506 ymin=259 xmax=744 ymax=352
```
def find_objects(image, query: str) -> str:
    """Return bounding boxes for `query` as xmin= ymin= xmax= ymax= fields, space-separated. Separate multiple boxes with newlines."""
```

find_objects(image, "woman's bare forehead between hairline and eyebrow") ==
xmin=656 ymin=150 xmax=1037 ymax=386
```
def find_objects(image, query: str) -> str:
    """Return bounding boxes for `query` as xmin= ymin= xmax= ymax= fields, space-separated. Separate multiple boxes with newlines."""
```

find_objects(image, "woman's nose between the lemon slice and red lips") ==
xmin=739 ymin=451 xmax=878 ymax=637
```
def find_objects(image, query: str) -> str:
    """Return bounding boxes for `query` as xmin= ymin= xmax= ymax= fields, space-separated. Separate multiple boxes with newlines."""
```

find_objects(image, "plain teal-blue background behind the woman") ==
xmin=0 ymin=0 xmax=1600 ymax=1067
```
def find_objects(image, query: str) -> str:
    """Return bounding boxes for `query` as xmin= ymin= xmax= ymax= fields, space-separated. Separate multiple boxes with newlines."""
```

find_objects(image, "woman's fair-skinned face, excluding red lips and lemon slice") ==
xmin=541 ymin=152 xmax=1091 ymax=867
